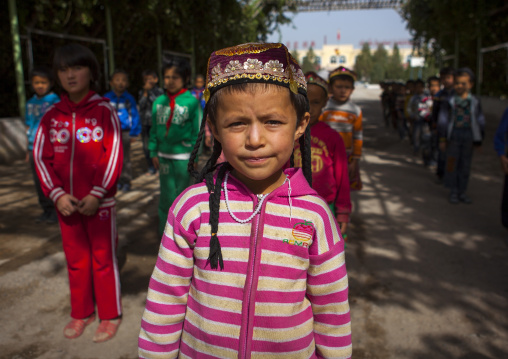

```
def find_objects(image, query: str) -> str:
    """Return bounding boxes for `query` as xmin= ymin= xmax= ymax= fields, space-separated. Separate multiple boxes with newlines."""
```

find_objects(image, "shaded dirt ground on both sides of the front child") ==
xmin=0 ymin=88 xmax=508 ymax=359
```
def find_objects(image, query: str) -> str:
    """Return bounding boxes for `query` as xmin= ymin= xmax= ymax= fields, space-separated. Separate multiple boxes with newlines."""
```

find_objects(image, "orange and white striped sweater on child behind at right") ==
xmin=319 ymin=97 xmax=363 ymax=159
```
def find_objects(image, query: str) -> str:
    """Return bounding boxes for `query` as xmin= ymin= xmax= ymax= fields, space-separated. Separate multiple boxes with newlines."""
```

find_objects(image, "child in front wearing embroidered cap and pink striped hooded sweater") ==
xmin=139 ymin=43 xmax=352 ymax=359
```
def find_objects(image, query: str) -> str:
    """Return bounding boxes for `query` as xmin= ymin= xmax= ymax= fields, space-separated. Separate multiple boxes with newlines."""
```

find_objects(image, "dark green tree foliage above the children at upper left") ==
xmin=0 ymin=0 xmax=291 ymax=116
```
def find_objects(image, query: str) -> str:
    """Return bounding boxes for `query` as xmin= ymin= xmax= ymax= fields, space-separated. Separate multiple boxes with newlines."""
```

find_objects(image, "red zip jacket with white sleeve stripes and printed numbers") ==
xmin=34 ymin=91 xmax=123 ymax=207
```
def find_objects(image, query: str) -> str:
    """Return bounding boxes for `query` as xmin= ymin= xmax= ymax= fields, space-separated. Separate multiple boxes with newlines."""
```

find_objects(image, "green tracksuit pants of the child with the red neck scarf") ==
xmin=159 ymin=156 xmax=190 ymax=236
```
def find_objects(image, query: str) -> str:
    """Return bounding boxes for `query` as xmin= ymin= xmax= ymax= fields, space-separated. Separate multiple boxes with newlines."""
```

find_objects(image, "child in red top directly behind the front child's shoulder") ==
xmin=295 ymin=72 xmax=351 ymax=237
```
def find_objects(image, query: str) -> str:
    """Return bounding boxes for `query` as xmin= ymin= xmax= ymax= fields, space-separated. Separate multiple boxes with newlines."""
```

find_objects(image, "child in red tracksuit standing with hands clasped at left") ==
xmin=34 ymin=44 xmax=122 ymax=342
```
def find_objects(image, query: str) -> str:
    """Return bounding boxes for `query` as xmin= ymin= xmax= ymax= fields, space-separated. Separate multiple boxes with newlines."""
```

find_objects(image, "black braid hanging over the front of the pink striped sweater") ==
xmin=207 ymin=162 xmax=230 ymax=270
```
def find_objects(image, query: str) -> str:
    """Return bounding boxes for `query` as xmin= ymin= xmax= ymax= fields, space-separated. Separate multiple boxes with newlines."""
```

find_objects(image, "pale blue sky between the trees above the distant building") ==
xmin=268 ymin=9 xmax=411 ymax=50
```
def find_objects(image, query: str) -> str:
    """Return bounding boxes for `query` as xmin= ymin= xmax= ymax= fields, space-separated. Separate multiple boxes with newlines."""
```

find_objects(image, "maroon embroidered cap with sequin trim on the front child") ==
xmin=203 ymin=43 xmax=307 ymax=102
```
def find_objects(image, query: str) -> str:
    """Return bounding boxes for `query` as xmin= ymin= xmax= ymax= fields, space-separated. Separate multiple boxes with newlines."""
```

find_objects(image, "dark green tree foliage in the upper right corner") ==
xmin=402 ymin=0 xmax=508 ymax=95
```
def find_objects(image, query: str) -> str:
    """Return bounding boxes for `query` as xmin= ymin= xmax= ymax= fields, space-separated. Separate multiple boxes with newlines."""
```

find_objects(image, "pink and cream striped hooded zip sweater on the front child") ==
xmin=139 ymin=168 xmax=352 ymax=358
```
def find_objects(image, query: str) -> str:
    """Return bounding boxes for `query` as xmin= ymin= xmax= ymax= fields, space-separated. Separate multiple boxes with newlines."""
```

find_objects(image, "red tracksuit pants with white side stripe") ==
xmin=57 ymin=206 xmax=122 ymax=319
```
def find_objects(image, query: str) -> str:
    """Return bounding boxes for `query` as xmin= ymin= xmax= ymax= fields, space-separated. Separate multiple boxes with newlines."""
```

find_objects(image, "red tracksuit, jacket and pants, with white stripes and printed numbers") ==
xmin=34 ymin=91 xmax=123 ymax=319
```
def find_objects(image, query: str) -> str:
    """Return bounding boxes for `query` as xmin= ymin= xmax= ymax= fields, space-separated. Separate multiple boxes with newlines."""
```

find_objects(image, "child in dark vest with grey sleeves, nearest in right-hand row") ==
xmin=438 ymin=67 xmax=485 ymax=204
